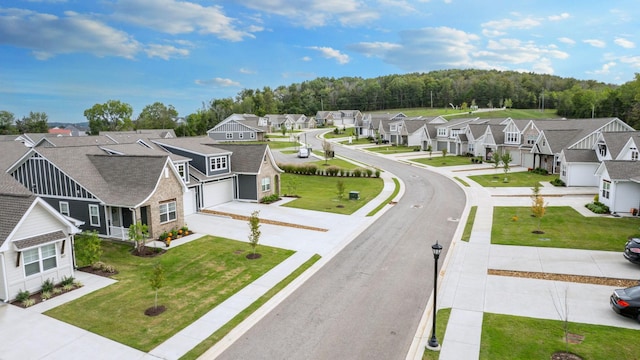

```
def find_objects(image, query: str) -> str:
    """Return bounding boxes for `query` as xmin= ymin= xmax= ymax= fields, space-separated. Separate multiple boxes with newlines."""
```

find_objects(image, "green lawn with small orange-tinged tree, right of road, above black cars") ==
xmin=491 ymin=206 xmax=640 ymax=252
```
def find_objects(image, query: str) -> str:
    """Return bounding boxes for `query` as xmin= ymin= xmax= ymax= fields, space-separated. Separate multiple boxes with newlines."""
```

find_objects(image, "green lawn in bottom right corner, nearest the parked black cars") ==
xmin=480 ymin=312 xmax=640 ymax=360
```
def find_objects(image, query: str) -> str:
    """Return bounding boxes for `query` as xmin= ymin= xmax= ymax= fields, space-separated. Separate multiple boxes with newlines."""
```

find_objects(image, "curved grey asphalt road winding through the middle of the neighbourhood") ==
xmin=218 ymin=133 xmax=465 ymax=359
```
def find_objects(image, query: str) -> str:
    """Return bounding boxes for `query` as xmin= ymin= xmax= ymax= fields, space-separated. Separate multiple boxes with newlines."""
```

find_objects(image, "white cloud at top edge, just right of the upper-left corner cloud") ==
xmin=113 ymin=0 xmax=262 ymax=41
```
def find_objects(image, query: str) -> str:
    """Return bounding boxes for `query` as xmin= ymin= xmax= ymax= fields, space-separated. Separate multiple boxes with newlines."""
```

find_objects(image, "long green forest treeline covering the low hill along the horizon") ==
xmin=0 ymin=69 xmax=640 ymax=136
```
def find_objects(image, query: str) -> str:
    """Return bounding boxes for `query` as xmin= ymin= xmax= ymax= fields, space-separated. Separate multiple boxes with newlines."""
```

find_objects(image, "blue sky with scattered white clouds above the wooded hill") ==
xmin=0 ymin=0 xmax=640 ymax=122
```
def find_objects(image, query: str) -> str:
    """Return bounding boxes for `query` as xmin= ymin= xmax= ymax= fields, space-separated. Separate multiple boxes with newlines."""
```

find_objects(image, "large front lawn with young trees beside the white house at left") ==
xmin=46 ymin=236 xmax=293 ymax=352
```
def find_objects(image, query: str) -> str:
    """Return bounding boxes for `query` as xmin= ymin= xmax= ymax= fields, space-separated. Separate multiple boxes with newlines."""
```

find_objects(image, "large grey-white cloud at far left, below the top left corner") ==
xmin=0 ymin=8 xmax=142 ymax=60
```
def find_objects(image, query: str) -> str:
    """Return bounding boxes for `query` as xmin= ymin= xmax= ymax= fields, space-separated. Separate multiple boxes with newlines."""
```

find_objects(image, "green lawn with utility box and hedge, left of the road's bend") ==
xmin=281 ymin=174 xmax=384 ymax=215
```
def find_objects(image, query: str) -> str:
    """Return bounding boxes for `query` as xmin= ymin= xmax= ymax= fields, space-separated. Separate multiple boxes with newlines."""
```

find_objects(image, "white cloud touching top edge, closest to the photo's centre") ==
xmin=236 ymin=0 xmax=378 ymax=28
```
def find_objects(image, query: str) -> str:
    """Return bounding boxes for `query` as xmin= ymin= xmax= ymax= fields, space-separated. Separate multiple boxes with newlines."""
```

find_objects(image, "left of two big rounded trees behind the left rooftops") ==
xmin=84 ymin=100 xmax=133 ymax=135
